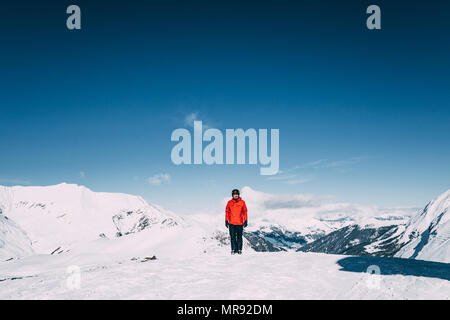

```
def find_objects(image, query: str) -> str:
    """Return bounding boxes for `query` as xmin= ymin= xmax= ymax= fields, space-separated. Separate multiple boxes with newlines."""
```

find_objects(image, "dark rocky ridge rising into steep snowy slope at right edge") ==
xmin=298 ymin=190 xmax=450 ymax=262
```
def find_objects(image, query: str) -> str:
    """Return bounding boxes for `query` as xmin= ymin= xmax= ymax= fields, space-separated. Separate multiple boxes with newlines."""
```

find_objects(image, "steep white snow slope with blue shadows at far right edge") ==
xmin=396 ymin=190 xmax=450 ymax=262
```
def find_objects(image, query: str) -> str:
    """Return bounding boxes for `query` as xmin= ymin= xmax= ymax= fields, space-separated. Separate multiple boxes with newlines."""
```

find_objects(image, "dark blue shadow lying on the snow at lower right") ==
xmin=337 ymin=256 xmax=450 ymax=281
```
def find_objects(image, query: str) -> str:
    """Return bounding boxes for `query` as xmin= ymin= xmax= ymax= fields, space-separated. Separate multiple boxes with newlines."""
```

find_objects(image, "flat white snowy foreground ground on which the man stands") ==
xmin=0 ymin=251 xmax=450 ymax=300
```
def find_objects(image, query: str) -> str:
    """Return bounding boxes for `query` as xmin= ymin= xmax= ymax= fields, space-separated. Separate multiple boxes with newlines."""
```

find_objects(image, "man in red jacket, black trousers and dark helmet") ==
xmin=225 ymin=189 xmax=247 ymax=254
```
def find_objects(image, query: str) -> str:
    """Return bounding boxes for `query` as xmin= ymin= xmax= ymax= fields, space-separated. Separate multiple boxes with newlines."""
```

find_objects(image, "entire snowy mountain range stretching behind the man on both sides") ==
xmin=0 ymin=183 xmax=450 ymax=262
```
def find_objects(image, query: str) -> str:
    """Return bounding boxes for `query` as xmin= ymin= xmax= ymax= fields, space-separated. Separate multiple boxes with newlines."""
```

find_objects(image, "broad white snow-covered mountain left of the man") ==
xmin=0 ymin=183 xmax=183 ymax=253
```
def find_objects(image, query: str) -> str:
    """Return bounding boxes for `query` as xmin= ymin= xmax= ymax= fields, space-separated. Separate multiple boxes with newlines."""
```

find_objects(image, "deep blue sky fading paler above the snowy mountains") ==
xmin=0 ymin=1 xmax=450 ymax=213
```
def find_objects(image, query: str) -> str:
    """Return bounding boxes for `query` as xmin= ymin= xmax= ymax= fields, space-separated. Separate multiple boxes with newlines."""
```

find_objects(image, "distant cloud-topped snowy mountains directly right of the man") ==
xmin=237 ymin=187 xmax=417 ymax=251
